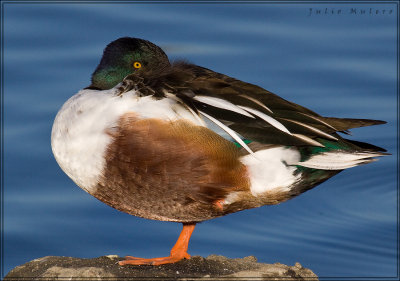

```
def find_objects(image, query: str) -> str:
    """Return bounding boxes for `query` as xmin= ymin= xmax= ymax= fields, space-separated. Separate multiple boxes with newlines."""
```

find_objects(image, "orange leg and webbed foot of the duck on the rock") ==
xmin=119 ymin=223 xmax=196 ymax=265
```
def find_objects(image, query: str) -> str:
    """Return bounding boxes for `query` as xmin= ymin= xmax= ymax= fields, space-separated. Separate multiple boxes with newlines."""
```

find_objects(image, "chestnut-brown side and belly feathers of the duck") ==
xmin=95 ymin=113 xmax=249 ymax=221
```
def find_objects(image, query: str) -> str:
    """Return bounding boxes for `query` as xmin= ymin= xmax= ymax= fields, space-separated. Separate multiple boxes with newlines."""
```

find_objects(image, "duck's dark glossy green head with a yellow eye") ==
xmin=88 ymin=37 xmax=170 ymax=90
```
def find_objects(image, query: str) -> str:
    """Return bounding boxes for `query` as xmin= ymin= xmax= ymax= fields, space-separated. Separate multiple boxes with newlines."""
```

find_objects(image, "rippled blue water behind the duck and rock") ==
xmin=2 ymin=3 xmax=398 ymax=278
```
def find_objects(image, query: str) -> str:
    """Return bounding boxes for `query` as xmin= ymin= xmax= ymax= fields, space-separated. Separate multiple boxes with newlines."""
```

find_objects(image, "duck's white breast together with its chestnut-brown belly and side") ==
xmin=52 ymin=87 xmax=249 ymax=222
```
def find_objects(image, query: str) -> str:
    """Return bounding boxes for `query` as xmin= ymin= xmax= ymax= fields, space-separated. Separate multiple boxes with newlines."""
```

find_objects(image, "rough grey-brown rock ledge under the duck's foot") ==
xmin=4 ymin=255 xmax=318 ymax=281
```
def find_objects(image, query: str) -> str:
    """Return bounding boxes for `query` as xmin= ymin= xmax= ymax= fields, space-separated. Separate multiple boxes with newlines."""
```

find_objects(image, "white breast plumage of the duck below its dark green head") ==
xmin=51 ymin=89 xmax=201 ymax=193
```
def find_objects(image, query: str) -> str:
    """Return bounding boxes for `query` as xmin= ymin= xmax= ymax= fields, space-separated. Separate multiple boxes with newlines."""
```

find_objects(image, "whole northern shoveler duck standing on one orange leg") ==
xmin=51 ymin=37 xmax=386 ymax=265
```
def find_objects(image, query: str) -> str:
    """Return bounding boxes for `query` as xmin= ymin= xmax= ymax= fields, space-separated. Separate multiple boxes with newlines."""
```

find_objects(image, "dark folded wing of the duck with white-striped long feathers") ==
xmin=136 ymin=62 xmax=385 ymax=153
